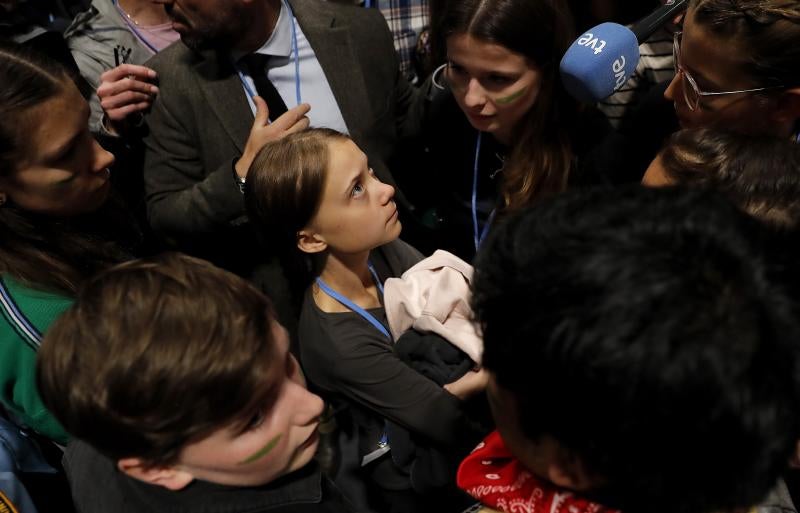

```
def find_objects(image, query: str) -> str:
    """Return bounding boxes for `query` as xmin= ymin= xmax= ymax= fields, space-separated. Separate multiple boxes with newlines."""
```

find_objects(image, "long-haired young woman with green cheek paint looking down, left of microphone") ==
xmin=401 ymin=0 xmax=609 ymax=259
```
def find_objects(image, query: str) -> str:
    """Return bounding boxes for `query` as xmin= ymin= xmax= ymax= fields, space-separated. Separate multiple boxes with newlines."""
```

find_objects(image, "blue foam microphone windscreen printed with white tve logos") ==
xmin=561 ymin=23 xmax=639 ymax=103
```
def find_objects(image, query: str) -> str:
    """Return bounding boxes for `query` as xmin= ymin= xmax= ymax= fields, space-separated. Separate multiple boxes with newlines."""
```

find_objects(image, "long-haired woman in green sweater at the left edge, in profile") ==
xmin=0 ymin=45 xmax=139 ymax=443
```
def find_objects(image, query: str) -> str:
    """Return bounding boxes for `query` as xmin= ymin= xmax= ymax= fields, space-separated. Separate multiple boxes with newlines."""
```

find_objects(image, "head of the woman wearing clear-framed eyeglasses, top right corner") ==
xmin=664 ymin=0 xmax=800 ymax=138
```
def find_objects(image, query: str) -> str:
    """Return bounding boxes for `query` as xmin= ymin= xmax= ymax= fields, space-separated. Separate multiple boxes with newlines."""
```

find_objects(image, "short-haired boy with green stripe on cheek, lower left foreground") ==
xmin=38 ymin=254 xmax=350 ymax=513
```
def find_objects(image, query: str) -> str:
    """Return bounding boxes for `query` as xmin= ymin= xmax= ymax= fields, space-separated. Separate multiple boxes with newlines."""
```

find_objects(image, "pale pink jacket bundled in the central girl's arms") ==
xmin=383 ymin=250 xmax=483 ymax=364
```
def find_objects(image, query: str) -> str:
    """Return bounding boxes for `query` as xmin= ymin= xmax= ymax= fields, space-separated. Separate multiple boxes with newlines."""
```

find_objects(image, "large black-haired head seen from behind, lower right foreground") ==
xmin=473 ymin=187 xmax=800 ymax=513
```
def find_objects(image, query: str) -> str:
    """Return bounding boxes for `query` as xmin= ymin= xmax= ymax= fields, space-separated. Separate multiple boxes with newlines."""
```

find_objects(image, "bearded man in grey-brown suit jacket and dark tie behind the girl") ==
xmin=144 ymin=0 xmax=419 ymax=275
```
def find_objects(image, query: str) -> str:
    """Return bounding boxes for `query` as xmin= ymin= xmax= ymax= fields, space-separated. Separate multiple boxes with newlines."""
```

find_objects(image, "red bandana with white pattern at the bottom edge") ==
xmin=456 ymin=431 xmax=618 ymax=513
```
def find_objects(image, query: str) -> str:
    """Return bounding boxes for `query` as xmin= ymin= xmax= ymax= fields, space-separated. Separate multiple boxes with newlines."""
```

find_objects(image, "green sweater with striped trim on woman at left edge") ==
xmin=0 ymin=276 xmax=73 ymax=445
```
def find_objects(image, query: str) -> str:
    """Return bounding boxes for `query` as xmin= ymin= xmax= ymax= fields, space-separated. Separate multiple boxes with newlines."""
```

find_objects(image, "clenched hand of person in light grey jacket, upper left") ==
xmin=97 ymin=64 xmax=158 ymax=132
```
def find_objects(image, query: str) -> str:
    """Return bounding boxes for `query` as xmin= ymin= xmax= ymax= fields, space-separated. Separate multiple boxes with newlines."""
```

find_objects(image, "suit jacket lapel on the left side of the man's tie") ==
xmin=196 ymin=51 xmax=253 ymax=153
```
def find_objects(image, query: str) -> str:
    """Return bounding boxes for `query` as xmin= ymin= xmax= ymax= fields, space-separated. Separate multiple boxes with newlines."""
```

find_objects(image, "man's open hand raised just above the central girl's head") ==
xmin=235 ymin=96 xmax=311 ymax=178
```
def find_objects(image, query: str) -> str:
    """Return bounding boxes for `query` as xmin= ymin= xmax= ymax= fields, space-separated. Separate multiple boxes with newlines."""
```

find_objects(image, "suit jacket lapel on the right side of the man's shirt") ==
xmin=290 ymin=0 xmax=375 ymax=137
